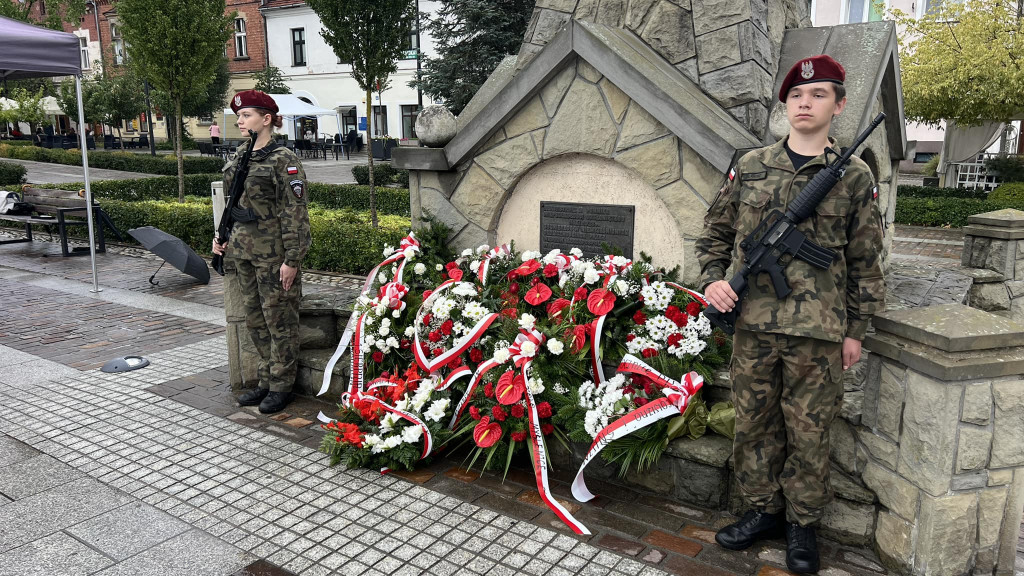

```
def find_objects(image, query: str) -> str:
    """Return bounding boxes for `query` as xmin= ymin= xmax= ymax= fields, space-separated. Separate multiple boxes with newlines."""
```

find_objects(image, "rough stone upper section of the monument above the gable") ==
xmin=516 ymin=0 xmax=811 ymax=137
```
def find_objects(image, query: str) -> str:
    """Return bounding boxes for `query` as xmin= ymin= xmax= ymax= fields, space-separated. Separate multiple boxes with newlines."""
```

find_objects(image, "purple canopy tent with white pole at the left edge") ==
xmin=0 ymin=16 xmax=99 ymax=292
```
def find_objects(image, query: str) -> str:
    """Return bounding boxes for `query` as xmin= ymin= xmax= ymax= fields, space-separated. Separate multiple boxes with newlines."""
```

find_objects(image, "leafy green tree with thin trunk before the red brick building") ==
xmin=118 ymin=0 xmax=234 ymax=202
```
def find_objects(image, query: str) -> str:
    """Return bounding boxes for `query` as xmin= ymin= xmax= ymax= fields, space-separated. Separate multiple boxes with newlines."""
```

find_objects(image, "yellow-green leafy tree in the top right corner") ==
xmin=891 ymin=0 xmax=1024 ymax=126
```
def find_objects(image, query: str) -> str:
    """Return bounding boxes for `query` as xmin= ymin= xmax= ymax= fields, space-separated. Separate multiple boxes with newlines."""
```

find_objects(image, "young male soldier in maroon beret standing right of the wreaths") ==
xmin=696 ymin=55 xmax=885 ymax=573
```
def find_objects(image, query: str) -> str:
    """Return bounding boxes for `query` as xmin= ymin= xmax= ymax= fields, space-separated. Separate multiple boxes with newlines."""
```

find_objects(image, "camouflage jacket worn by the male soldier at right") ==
xmin=696 ymin=136 xmax=885 ymax=342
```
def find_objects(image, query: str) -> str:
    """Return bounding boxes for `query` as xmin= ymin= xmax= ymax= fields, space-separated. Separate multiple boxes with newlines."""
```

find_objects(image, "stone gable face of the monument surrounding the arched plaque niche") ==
xmin=410 ymin=58 xmax=724 ymax=281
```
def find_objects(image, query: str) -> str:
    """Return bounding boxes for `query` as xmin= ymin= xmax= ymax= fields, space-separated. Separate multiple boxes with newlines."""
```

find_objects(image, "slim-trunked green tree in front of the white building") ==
xmin=306 ymin=0 xmax=416 ymax=228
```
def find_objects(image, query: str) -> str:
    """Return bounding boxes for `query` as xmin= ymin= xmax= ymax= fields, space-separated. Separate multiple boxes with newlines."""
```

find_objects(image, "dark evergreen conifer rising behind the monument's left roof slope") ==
xmin=410 ymin=0 xmax=536 ymax=114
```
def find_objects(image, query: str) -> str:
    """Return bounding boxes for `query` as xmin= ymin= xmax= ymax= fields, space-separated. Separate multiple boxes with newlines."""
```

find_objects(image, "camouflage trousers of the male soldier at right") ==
xmin=729 ymin=330 xmax=843 ymax=526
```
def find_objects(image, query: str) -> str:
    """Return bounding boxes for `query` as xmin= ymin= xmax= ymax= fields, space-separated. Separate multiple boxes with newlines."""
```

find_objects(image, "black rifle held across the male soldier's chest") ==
xmin=703 ymin=114 xmax=886 ymax=334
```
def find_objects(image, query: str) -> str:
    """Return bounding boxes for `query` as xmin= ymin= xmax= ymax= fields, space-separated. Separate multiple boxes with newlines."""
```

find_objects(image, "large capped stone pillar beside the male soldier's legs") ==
xmin=856 ymin=304 xmax=1024 ymax=576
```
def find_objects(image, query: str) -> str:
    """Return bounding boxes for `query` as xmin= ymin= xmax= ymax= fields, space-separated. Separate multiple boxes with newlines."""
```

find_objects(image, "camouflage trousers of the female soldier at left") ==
xmin=230 ymin=258 xmax=302 ymax=392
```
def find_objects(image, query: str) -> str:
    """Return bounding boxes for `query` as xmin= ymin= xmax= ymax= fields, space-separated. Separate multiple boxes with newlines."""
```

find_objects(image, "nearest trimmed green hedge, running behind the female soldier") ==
xmin=100 ymin=199 xmax=410 ymax=274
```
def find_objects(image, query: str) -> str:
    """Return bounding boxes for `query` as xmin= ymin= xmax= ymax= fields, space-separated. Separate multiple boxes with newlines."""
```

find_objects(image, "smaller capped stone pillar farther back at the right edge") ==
xmin=961 ymin=208 xmax=1024 ymax=322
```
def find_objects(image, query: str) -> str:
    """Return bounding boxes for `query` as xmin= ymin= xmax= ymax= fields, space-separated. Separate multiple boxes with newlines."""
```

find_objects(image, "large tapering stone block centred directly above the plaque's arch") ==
xmin=544 ymin=80 xmax=617 ymax=156
